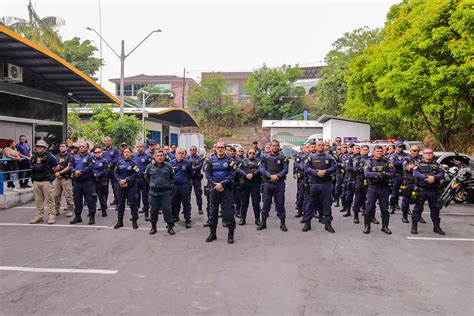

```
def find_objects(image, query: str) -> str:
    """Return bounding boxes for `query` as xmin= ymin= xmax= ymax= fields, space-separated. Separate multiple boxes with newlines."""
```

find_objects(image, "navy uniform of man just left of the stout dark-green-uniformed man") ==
xmin=114 ymin=158 xmax=139 ymax=220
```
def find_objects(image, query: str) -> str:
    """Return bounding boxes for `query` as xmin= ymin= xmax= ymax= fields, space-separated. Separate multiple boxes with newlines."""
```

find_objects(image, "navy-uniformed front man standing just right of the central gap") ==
xmin=302 ymin=140 xmax=337 ymax=233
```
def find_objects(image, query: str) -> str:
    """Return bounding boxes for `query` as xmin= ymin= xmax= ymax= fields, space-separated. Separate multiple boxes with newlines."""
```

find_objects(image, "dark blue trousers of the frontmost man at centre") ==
xmin=209 ymin=186 xmax=235 ymax=229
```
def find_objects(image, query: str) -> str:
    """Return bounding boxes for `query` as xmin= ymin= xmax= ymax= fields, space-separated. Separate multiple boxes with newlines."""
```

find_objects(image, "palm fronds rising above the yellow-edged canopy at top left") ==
xmin=0 ymin=0 xmax=64 ymax=52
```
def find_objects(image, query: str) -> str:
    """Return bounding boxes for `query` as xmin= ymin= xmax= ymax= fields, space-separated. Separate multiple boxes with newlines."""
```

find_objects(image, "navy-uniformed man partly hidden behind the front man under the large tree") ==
xmin=352 ymin=145 xmax=369 ymax=224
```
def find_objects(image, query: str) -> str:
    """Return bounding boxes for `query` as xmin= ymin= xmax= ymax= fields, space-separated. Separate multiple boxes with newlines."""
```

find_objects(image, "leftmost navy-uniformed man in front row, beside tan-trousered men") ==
xmin=70 ymin=141 xmax=97 ymax=225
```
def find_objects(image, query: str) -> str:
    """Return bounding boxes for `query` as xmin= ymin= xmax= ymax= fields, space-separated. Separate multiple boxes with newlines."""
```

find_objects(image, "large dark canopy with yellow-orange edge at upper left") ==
xmin=0 ymin=25 xmax=120 ymax=104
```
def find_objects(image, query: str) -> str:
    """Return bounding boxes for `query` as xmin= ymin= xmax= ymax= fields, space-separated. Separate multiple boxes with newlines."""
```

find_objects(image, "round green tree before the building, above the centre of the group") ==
xmin=245 ymin=65 xmax=305 ymax=119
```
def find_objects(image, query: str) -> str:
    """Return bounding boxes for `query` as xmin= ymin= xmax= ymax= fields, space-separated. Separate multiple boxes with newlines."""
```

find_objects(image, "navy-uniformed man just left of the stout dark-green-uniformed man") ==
xmin=114 ymin=148 xmax=139 ymax=229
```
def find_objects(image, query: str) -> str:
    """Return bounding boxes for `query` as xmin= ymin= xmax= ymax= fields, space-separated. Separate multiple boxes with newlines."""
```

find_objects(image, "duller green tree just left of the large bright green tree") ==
xmin=316 ymin=27 xmax=381 ymax=115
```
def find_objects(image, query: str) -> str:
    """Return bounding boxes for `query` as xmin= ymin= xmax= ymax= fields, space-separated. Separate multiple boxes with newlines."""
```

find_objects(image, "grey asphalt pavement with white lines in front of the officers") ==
xmin=0 ymin=172 xmax=474 ymax=315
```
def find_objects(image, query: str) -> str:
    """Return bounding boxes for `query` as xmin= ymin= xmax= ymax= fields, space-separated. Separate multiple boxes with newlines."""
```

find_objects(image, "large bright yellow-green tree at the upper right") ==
xmin=345 ymin=0 xmax=474 ymax=150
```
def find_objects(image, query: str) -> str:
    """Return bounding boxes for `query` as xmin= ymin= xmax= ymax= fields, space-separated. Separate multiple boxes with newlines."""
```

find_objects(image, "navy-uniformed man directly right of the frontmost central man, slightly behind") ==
xmin=237 ymin=148 xmax=262 ymax=226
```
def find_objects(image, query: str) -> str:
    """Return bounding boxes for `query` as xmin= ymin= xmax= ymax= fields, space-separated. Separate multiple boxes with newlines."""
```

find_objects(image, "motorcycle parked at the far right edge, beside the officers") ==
xmin=440 ymin=162 xmax=474 ymax=207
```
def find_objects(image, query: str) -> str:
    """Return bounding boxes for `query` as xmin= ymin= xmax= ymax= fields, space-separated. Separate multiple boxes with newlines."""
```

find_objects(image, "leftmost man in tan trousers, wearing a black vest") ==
xmin=30 ymin=140 xmax=59 ymax=224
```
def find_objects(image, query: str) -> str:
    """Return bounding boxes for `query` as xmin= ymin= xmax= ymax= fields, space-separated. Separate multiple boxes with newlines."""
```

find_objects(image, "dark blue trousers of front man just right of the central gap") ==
xmin=304 ymin=182 xmax=332 ymax=223
